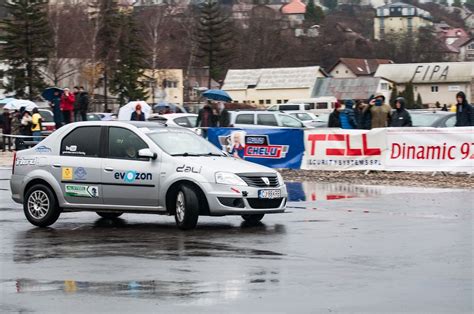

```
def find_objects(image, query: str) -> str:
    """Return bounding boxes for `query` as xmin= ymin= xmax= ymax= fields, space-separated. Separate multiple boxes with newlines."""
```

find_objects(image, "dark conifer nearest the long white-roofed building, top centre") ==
xmin=193 ymin=0 xmax=234 ymax=88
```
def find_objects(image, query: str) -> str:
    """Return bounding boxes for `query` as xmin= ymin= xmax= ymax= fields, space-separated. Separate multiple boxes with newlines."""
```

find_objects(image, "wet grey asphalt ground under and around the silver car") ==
xmin=0 ymin=169 xmax=474 ymax=313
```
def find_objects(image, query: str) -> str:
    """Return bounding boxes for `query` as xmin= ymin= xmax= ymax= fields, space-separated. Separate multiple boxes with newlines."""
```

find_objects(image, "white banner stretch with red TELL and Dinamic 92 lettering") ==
xmin=301 ymin=127 xmax=474 ymax=172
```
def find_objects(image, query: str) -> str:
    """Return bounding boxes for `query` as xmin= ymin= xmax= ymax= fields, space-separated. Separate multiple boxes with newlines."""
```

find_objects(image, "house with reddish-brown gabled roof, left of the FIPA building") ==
xmin=328 ymin=58 xmax=393 ymax=78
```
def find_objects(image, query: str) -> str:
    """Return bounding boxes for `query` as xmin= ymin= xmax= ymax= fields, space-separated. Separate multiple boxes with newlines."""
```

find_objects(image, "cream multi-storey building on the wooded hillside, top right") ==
xmin=374 ymin=2 xmax=433 ymax=40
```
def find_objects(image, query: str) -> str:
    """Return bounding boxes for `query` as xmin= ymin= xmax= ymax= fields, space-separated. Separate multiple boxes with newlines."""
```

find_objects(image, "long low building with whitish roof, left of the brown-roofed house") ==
xmin=222 ymin=66 xmax=328 ymax=107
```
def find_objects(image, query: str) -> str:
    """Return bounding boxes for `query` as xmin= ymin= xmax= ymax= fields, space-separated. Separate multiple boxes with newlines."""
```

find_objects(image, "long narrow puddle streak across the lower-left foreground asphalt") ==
xmin=0 ymin=271 xmax=280 ymax=303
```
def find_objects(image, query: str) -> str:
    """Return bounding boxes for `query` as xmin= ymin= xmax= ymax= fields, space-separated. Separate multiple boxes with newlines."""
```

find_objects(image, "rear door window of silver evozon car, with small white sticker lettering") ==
xmin=61 ymin=126 xmax=100 ymax=157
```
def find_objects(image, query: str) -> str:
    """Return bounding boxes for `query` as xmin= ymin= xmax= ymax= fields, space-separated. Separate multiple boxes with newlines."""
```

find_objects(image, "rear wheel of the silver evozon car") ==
xmin=23 ymin=184 xmax=61 ymax=227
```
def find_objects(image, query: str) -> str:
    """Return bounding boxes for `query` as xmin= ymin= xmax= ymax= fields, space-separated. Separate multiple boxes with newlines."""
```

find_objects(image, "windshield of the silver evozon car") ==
xmin=147 ymin=131 xmax=224 ymax=156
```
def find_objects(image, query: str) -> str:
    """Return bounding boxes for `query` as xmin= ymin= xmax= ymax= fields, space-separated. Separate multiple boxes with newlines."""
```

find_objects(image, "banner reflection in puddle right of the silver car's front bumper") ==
xmin=287 ymin=182 xmax=383 ymax=202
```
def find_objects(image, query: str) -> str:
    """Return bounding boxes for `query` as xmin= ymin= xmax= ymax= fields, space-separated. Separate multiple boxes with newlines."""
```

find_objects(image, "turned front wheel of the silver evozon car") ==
xmin=174 ymin=185 xmax=199 ymax=230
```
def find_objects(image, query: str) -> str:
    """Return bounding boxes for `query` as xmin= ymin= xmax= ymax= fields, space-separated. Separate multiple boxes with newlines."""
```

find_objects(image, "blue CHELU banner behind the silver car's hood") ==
xmin=208 ymin=128 xmax=305 ymax=169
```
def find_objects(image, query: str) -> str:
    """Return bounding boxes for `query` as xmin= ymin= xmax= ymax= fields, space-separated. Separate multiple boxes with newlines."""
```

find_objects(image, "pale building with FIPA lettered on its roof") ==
xmin=374 ymin=62 xmax=474 ymax=105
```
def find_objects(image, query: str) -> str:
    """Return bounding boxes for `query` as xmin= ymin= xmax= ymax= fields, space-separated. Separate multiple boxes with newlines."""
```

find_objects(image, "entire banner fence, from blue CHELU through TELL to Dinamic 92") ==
xmin=208 ymin=127 xmax=474 ymax=173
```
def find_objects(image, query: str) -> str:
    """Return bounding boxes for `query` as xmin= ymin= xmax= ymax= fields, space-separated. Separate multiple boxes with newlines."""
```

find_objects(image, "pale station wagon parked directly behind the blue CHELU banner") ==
xmin=229 ymin=111 xmax=305 ymax=128
